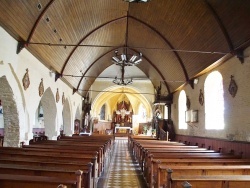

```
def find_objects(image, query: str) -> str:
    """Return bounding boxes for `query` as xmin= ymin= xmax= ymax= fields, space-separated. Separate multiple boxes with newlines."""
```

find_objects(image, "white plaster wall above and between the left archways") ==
xmin=0 ymin=28 xmax=81 ymax=142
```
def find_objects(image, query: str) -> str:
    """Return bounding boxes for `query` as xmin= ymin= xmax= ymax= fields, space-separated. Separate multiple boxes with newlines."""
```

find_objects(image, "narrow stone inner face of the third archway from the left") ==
xmin=63 ymin=99 xmax=72 ymax=135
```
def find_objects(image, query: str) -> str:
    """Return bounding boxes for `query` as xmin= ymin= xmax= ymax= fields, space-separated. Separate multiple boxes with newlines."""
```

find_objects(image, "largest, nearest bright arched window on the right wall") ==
xmin=204 ymin=71 xmax=225 ymax=129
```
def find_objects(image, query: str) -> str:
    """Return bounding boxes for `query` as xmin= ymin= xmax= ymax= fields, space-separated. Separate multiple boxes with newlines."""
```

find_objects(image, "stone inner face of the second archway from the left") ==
xmin=41 ymin=88 xmax=57 ymax=139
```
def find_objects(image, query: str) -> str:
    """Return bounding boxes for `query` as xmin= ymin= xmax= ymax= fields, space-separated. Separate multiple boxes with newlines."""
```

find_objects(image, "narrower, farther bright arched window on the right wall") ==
xmin=178 ymin=90 xmax=187 ymax=129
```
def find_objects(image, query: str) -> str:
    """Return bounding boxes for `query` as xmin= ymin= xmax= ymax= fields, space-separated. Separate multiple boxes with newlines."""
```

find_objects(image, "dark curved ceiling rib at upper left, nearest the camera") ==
xmin=16 ymin=0 xmax=55 ymax=54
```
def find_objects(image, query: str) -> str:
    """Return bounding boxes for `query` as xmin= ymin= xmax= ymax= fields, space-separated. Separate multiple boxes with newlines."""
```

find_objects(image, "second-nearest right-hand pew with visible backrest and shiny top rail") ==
xmin=159 ymin=165 xmax=250 ymax=188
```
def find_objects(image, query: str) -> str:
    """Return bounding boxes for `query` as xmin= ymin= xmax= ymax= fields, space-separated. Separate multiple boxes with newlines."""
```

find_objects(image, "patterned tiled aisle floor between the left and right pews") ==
xmin=98 ymin=137 xmax=147 ymax=188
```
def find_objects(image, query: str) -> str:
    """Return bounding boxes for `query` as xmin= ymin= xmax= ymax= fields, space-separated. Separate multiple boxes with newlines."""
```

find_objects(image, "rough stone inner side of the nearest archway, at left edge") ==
xmin=0 ymin=76 xmax=20 ymax=147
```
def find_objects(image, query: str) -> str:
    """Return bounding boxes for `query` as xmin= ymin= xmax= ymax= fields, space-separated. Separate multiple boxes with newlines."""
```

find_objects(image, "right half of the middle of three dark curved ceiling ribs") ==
xmin=129 ymin=16 xmax=189 ymax=81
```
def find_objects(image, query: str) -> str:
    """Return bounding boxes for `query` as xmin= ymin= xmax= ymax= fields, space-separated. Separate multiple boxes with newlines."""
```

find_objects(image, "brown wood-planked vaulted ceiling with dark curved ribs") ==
xmin=0 ymin=0 xmax=250 ymax=96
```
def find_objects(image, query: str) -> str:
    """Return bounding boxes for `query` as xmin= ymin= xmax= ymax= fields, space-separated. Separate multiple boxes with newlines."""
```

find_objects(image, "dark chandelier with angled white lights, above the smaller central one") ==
xmin=112 ymin=50 xmax=142 ymax=66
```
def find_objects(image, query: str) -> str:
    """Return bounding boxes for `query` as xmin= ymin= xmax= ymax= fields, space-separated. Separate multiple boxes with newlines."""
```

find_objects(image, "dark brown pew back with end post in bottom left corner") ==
xmin=0 ymin=171 xmax=82 ymax=188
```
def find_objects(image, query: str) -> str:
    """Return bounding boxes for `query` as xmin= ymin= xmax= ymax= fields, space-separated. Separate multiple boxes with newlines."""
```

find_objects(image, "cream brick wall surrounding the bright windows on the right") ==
xmin=172 ymin=48 xmax=250 ymax=142
